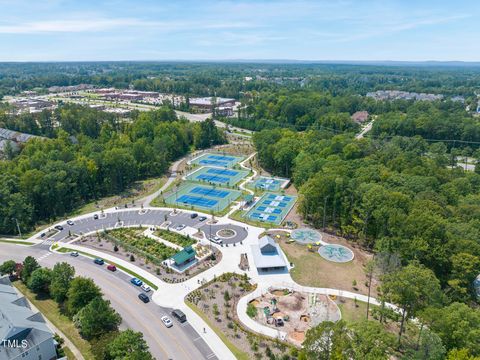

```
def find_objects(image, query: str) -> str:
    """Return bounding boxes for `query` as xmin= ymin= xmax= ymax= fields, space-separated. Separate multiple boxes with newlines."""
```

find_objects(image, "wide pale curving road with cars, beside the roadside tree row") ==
xmin=0 ymin=243 xmax=217 ymax=360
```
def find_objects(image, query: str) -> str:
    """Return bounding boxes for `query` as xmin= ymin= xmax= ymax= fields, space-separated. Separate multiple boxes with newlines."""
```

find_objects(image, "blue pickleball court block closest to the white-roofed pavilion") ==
xmin=246 ymin=192 xmax=297 ymax=225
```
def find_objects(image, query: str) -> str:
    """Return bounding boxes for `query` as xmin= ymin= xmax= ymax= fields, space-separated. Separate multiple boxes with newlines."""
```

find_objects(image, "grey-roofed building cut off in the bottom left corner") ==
xmin=0 ymin=276 xmax=57 ymax=360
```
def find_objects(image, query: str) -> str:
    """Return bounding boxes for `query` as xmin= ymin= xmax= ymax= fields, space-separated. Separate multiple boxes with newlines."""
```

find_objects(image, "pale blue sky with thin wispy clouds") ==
xmin=0 ymin=0 xmax=480 ymax=61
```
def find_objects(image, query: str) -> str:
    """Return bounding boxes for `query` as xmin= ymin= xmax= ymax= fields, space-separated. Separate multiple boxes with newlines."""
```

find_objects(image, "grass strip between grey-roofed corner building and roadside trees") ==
xmin=13 ymin=281 xmax=94 ymax=360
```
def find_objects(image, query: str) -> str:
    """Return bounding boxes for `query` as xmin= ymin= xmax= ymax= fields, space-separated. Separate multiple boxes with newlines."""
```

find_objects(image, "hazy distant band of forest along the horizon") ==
xmin=0 ymin=62 xmax=480 ymax=98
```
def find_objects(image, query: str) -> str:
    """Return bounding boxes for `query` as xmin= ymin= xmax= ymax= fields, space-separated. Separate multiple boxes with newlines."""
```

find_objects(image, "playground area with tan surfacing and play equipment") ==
xmin=250 ymin=288 xmax=341 ymax=345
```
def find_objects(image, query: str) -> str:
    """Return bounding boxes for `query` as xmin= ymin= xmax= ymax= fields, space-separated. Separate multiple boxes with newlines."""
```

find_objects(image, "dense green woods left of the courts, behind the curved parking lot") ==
xmin=0 ymin=105 xmax=225 ymax=234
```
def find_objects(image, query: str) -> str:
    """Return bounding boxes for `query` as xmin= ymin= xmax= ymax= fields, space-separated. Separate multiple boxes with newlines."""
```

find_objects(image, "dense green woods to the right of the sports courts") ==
xmin=253 ymin=129 xmax=480 ymax=355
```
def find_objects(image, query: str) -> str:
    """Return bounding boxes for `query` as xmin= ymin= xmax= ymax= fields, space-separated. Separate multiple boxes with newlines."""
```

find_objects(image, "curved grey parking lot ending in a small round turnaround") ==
xmin=46 ymin=209 xmax=248 ymax=245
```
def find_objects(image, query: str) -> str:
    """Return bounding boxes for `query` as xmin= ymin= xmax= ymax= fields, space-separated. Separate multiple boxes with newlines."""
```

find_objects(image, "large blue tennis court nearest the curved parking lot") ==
xmin=164 ymin=182 xmax=241 ymax=211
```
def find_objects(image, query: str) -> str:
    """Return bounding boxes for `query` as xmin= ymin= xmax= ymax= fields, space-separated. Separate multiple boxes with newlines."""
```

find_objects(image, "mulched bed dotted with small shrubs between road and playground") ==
xmin=186 ymin=273 xmax=297 ymax=360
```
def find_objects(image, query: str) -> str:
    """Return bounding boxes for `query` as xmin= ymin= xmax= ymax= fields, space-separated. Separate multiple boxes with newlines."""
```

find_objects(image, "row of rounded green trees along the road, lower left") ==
xmin=0 ymin=256 xmax=153 ymax=360
